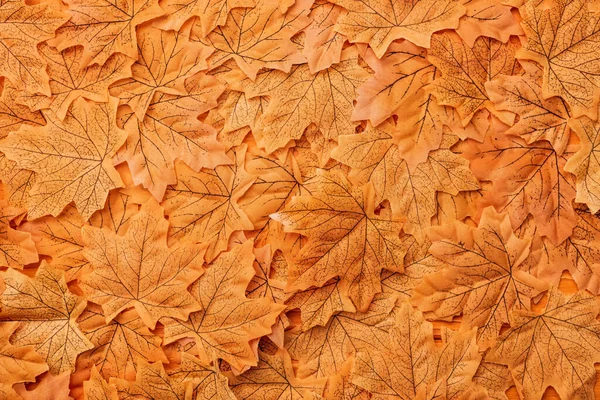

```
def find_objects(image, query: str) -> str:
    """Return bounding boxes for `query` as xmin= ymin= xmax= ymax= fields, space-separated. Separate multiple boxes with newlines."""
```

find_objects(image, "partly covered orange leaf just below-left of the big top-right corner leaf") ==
xmin=485 ymin=64 xmax=571 ymax=154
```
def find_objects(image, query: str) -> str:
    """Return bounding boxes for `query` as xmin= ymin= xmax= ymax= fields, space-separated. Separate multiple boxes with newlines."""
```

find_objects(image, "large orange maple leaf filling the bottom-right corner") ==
xmin=490 ymin=288 xmax=600 ymax=400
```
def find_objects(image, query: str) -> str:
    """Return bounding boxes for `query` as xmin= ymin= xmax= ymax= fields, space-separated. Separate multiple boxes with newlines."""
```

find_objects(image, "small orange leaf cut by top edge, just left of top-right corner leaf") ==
xmin=456 ymin=0 xmax=523 ymax=47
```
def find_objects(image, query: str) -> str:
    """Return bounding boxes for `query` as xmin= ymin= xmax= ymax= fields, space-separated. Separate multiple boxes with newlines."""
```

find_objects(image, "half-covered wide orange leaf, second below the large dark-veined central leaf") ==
xmin=286 ymin=294 xmax=397 ymax=378
